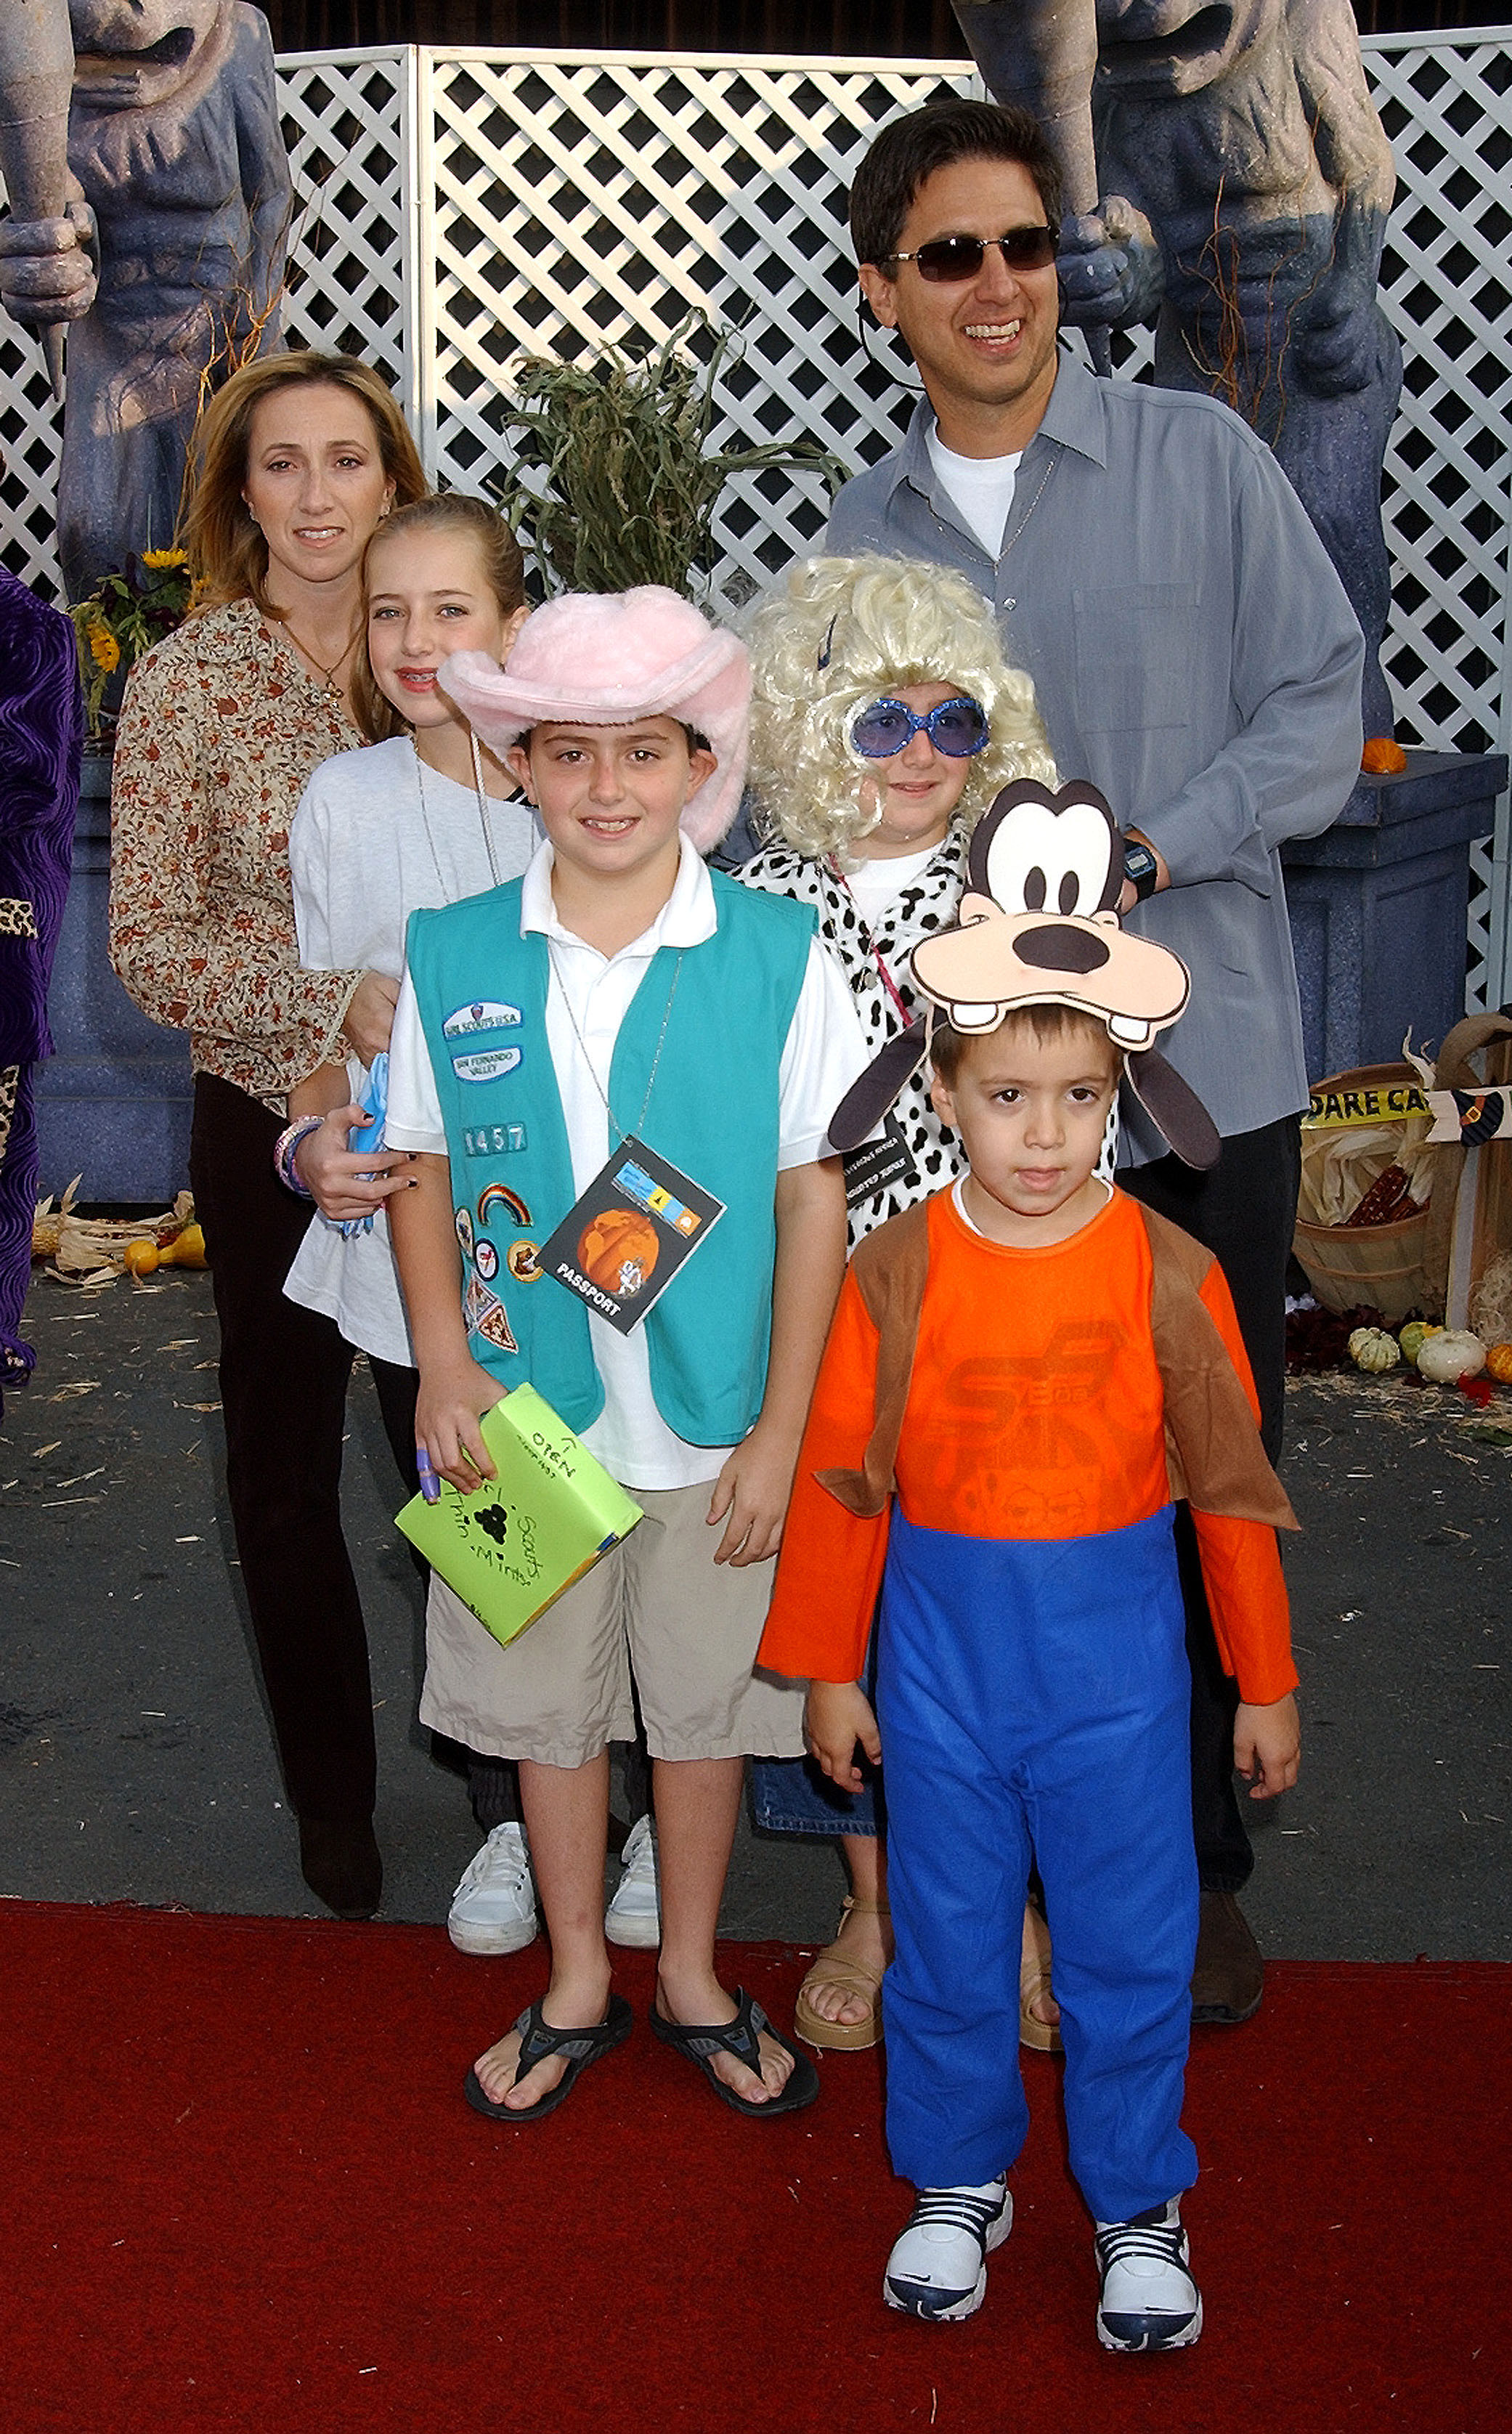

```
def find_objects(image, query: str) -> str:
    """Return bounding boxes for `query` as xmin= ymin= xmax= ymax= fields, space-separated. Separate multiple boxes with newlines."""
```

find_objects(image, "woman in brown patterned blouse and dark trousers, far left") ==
xmin=110 ymin=353 xmax=426 ymax=1918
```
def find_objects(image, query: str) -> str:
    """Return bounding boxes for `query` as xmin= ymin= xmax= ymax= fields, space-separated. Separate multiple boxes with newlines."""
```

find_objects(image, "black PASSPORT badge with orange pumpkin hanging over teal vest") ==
xmin=540 ymin=1139 xmax=725 ymax=1336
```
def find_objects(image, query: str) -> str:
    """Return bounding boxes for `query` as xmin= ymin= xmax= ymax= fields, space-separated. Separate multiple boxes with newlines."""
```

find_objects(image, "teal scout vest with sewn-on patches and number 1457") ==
xmin=407 ymin=872 xmax=816 ymax=1445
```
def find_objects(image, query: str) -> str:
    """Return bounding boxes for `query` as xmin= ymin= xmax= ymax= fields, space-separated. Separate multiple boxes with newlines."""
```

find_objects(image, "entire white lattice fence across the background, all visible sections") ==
xmin=0 ymin=29 xmax=1512 ymax=1003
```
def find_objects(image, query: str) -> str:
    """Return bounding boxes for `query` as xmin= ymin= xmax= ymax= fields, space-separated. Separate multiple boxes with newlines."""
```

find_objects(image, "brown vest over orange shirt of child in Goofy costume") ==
xmin=818 ymin=1202 xmax=1300 ymax=1528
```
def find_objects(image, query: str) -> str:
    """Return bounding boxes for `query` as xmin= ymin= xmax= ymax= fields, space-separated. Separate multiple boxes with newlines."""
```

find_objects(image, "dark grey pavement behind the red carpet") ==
xmin=0 ymin=1273 xmax=1512 ymax=1960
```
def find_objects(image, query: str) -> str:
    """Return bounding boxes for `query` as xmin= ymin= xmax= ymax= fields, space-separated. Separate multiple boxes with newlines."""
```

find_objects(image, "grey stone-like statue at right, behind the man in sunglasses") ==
xmin=957 ymin=0 xmax=1402 ymax=735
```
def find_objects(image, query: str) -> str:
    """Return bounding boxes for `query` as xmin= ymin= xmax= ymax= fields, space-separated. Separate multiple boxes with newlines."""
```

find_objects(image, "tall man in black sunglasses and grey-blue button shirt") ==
xmin=826 ymin=100 xmax=1363 ymax=2023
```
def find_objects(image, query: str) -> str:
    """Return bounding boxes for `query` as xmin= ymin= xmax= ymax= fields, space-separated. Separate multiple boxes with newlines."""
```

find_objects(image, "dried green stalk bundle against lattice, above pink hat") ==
xmin=499 ymin=312 xmax=848 ymax=596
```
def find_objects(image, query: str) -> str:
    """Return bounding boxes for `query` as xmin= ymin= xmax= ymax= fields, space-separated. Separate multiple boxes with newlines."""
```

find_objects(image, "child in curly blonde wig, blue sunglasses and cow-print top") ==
xmin=738 ymin=557 xmax=1057 ymax=2050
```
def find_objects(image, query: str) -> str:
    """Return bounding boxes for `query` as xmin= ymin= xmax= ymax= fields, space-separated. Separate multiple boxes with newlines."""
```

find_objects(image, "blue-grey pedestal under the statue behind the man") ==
xmin=1280 ymin=752 xmax=1507 ymax=1081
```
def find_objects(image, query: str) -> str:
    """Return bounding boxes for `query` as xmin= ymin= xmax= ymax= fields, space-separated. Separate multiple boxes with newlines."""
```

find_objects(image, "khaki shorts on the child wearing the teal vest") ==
xmin=419 ymin=1485 xmax=803 ymax=1767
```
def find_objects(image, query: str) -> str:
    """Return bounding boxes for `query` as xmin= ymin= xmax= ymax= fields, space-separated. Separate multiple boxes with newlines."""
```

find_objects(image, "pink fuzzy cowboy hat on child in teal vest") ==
xmin=441 ymin=584 xmax=750 ymax=854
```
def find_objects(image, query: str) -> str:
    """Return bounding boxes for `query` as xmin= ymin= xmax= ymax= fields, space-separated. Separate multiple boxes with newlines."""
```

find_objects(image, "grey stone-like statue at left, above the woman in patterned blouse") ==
xmin=0 ymin=0 xmax=290 ymax=599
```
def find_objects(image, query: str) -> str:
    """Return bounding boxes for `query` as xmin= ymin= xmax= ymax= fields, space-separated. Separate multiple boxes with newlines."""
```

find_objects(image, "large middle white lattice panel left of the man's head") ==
xmin=421 ymin=54 xmax=979 ymax=599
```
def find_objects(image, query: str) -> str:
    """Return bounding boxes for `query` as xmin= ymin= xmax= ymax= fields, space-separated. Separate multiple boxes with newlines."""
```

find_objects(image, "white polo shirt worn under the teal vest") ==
xmin=385 ymin=837 xmax=867 ymax=1487
